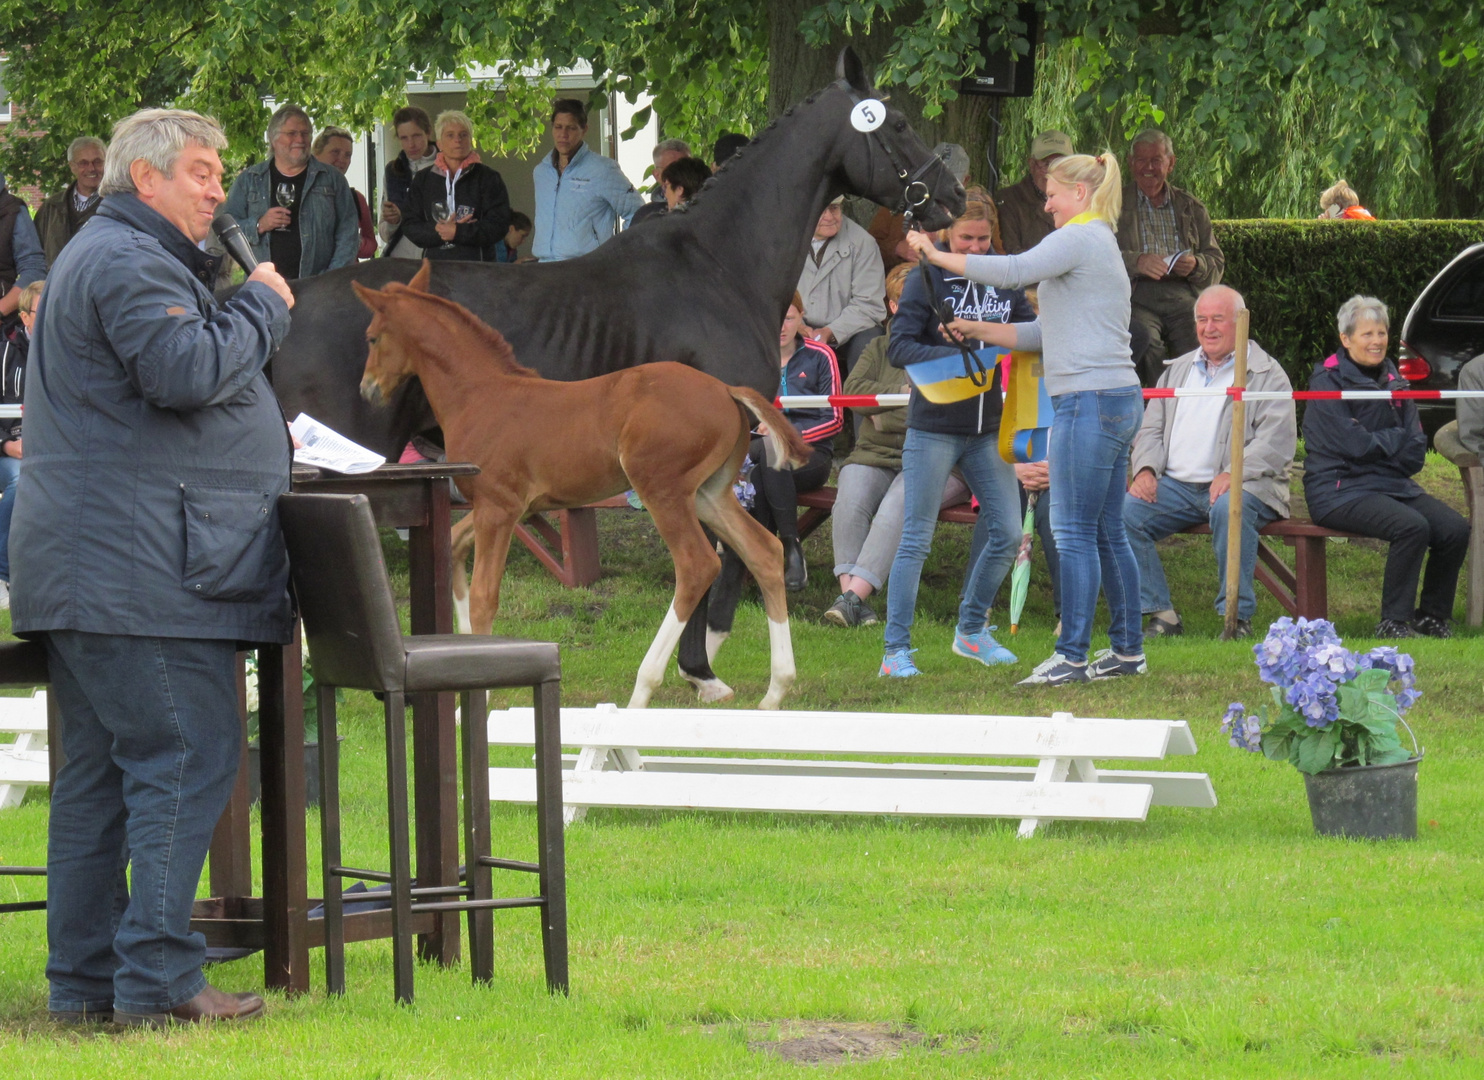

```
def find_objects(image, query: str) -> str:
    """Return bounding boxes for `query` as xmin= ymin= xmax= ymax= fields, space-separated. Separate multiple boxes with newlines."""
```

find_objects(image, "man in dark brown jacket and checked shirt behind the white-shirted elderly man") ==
xmin=1117 ymin=128 xmax=1226 ymax=386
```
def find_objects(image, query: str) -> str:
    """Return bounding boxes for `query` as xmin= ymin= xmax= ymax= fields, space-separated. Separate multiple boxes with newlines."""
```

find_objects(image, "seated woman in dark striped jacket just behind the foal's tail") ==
xmin=748 ymin=291 xmax=844 ymax=592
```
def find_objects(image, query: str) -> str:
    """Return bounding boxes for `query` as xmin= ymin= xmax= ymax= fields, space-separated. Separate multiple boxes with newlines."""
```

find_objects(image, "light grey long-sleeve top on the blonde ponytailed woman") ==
xmin=965 ymin=221 xmax=1138 ymax=398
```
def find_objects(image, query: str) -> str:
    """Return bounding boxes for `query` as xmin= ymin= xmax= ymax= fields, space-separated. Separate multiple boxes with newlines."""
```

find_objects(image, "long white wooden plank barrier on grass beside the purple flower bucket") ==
xmin=488 ymin=705 xmax=1215 ymax=837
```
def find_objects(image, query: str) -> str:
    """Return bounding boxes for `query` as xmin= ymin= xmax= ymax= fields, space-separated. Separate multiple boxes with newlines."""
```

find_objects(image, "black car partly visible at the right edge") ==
xmin=1396 ymin=243 xmax=1484 ymax=441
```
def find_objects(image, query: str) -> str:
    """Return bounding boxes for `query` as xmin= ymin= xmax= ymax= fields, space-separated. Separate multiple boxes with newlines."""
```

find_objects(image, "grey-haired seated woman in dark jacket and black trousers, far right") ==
xmin=1303 ymin=297 xmax=1469 ymax=638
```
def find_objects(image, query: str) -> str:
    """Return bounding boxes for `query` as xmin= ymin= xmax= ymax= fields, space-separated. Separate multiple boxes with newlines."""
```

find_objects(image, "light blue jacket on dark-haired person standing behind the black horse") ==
xmin=531 ymin=145 xmax=644 ymax=263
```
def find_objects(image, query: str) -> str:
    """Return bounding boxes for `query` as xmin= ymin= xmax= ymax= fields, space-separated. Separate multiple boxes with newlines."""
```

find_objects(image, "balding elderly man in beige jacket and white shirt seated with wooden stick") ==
xmin=1123 ymin=285 xmax=1299 ymax=638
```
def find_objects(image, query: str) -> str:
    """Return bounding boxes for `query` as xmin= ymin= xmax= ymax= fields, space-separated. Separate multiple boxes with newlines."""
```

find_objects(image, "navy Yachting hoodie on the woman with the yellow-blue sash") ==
xmin=886 ymin=245 xmax=1036 ymax=435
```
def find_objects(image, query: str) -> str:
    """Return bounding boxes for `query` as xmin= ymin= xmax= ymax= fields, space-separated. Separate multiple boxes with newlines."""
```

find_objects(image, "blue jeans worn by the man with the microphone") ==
xmin=46 ymin=630 xmax=242 ymax=1012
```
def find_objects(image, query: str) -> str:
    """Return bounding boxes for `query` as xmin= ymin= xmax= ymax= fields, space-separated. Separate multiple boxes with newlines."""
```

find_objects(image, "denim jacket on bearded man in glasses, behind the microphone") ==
xmin=221 ymin=157 xmax=361 ymax=277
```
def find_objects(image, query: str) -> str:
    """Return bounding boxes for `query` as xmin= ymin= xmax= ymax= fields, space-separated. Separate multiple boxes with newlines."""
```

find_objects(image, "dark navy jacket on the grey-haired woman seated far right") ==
xmin=1299 ymin=347 xmax=1428 ymax=521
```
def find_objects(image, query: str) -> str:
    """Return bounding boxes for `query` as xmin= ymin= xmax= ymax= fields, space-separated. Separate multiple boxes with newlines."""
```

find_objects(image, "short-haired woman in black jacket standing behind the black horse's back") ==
xmin=402 ymin=111 xmax=510 ymax=263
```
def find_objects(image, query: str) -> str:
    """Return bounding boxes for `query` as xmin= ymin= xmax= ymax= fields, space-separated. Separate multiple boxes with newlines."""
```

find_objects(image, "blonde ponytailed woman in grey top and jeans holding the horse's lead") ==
xmin=908 ymin=151 xmax=1147 ymax=685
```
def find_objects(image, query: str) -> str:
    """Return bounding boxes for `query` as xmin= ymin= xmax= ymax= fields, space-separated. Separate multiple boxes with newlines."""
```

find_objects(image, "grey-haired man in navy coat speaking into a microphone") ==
xmin=10 ymin=108 xmax=294 ymax=1027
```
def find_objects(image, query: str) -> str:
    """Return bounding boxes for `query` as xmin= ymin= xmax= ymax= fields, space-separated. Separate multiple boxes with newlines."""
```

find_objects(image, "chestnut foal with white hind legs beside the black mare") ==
xmin=353 ymin=260 xmax=809 ymax=709
